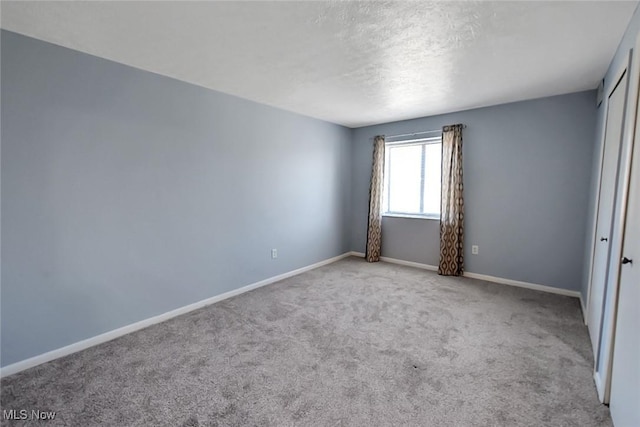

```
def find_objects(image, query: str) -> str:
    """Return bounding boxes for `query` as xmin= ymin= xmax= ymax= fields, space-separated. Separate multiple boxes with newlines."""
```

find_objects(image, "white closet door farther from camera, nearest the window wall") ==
xmin=587 ymin=69 xmax=627 ymax=361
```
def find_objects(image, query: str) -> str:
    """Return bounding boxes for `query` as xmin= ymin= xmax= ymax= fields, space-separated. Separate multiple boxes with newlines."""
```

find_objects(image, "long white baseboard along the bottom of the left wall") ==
xmin=0 ymin=252 xmax=352 ymax=378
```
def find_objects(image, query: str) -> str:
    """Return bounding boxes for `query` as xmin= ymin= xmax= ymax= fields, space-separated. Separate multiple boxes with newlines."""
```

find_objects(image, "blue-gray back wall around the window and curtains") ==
xmin=351 ymin=91 xmax=596 ymax=290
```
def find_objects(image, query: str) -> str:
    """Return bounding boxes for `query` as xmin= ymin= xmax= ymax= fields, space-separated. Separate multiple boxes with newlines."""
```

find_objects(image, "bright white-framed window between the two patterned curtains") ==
xmin=383 ymin=136 xmax=442 ymax=218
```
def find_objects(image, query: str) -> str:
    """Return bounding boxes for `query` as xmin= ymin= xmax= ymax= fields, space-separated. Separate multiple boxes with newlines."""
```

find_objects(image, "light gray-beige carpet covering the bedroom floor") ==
xmin=1 ymin=258 xmax=611 ymax=427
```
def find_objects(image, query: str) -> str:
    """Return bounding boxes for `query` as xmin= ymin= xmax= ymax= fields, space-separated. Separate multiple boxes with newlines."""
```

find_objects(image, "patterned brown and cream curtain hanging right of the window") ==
xmin=438 ymin=125 xmax=464 ymax=276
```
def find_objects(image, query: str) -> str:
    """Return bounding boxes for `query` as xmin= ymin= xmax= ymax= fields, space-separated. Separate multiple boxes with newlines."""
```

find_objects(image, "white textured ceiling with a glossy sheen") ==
xmin=1 ymin=1 xmax=637 ymax=127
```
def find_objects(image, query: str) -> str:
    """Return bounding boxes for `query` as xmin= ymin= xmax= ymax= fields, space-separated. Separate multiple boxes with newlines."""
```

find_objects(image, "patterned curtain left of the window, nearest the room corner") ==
xmin=365 ymin=136 xmax=384 ymax=262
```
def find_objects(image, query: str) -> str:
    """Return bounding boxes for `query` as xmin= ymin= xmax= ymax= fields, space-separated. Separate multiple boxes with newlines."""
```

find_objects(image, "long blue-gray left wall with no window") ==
xmin=1 ymin=31 xmax=351 ymax=366
